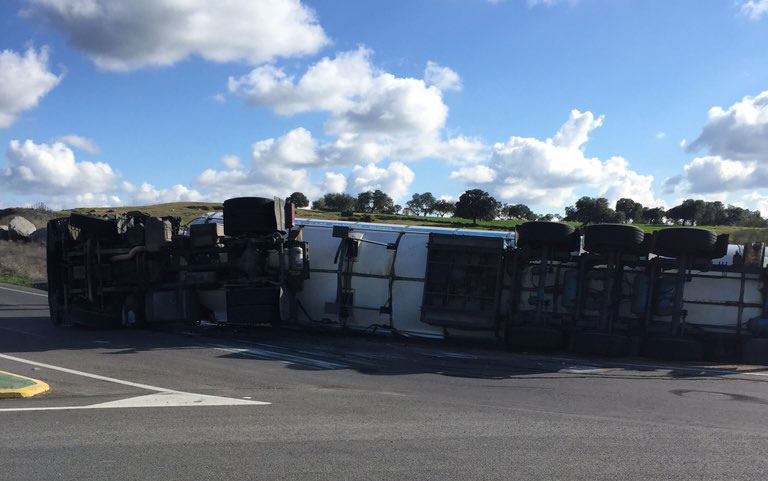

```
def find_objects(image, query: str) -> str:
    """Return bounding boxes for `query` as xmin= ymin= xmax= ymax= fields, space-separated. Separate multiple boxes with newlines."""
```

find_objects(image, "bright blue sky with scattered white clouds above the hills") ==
xmin=0 ymin=0 xmax=768 ymax=212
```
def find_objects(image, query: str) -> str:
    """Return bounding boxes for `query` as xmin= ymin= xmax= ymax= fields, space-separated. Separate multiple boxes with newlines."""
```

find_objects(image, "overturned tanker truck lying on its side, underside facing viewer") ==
xmin=48 ymin=197 xmax=768 ymax=362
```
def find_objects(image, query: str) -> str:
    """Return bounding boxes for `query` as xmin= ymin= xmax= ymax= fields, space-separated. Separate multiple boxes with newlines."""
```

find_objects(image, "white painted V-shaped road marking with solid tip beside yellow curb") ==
xmin=0 ymin=354 xmax=271 ymax=412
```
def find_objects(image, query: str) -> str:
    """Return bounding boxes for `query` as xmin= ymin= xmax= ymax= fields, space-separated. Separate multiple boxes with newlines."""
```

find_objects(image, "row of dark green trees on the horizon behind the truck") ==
xmin=286 ymin=189 xmax=768 ymax=227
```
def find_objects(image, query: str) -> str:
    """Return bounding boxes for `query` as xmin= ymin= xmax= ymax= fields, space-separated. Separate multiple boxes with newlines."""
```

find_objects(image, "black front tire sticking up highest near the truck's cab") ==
xmin=224 ymin=197 xmax=280 ymax=236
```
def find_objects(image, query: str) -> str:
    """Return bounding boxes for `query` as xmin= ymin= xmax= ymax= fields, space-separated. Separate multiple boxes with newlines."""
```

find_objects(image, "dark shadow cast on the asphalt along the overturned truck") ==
xmin=0 ymin=305 xmax=768 ymax=381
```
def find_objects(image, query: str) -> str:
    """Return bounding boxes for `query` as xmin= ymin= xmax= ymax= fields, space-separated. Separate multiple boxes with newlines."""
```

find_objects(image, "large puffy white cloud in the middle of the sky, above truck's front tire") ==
xmin=228 ymin=47 xmax=474 ymax=164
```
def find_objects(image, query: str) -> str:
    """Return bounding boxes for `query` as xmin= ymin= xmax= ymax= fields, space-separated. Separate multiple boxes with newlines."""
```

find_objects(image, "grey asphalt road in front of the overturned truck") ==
xmin=0 ymin=286 xmax=768 ymax=481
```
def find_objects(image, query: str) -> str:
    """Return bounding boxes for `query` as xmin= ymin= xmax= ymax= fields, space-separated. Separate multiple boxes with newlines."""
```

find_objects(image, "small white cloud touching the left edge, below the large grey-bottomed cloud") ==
xmin=0 ymin=47 xmax=61 ymax=129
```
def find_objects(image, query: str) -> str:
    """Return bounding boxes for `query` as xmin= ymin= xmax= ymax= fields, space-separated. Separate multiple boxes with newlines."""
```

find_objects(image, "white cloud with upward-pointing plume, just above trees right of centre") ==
xmin=451 ymin=110 xmax=659 ymax=207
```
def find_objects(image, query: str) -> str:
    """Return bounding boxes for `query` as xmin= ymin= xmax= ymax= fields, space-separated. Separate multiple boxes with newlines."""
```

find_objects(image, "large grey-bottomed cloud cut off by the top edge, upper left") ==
xmin=23 ymin=0 xmax=328 ymax=71
